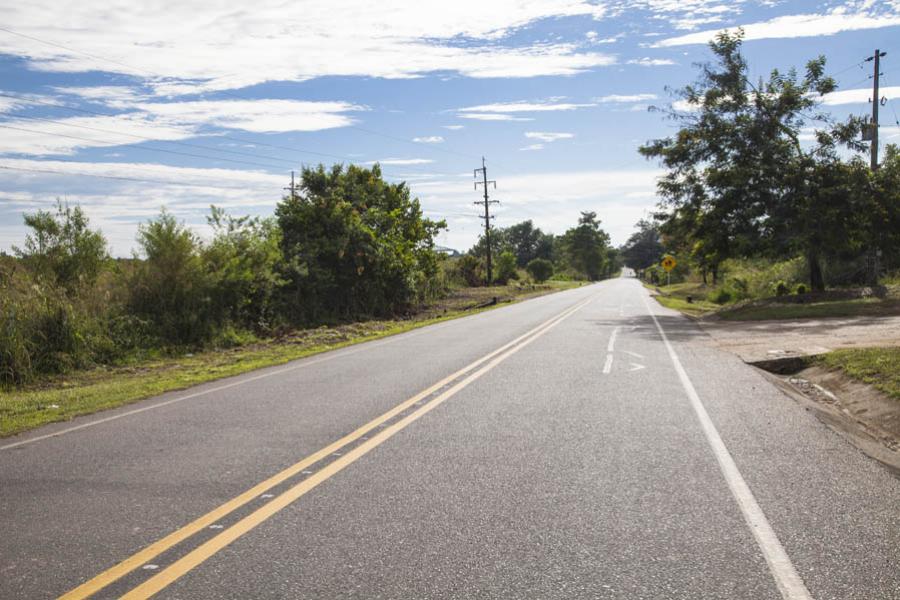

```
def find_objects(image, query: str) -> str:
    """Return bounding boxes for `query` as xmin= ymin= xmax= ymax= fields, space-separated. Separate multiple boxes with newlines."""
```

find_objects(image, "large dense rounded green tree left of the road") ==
xmin=275 ymin=165 xmax=446 ymax=322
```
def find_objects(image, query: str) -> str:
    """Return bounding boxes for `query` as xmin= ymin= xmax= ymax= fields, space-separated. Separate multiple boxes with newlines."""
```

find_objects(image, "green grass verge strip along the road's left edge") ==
xmin=0 ymin=281 xmax=582 ymax=437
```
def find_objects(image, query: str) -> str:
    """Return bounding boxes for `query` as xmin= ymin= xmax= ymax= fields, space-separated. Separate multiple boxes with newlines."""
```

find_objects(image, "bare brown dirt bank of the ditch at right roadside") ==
xmin=766 ymin=366 xmax=900 ymax=476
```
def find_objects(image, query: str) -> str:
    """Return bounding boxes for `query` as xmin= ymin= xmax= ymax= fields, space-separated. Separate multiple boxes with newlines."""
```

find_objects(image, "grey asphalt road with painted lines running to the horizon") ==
xmin=0 ymin=279 xmax=900 ymax=600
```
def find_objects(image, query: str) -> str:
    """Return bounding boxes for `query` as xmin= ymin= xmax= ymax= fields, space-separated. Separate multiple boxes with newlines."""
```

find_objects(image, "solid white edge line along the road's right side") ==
xmin=641 ymin=294 xmax=812 ymax=600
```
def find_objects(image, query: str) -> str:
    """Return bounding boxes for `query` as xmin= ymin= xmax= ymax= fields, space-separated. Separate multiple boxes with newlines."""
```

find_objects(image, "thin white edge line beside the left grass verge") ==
xmin=0 ymin=286 xmax=589 ymax=451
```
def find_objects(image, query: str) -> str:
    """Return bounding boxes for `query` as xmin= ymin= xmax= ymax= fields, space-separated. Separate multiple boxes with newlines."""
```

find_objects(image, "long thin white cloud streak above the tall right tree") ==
xmin=655 ymin=8 xmax=900 ymax=47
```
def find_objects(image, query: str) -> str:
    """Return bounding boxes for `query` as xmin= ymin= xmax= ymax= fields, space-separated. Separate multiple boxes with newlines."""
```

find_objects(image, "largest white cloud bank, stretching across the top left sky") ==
xmin=0 ymin=0 xmax=615 ymax=94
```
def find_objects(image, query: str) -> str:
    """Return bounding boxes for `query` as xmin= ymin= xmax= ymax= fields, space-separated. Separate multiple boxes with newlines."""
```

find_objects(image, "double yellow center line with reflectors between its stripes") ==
xmin=61 ymin=298 xmax=593 ymax=600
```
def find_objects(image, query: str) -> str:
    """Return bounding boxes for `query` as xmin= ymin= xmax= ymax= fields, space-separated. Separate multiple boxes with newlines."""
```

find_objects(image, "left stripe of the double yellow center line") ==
xmin=60 ymin=292 xmax=589 ymax=600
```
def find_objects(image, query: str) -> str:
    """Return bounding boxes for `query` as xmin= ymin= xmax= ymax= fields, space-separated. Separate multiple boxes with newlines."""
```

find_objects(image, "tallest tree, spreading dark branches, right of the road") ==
xmin=640 ymin=31 xmax=860 ymax=290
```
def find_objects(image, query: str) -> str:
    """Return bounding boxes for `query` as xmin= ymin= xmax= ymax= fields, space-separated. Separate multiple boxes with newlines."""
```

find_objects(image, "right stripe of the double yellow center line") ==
xmin=122 ymin=292 xmax=591 ymax=600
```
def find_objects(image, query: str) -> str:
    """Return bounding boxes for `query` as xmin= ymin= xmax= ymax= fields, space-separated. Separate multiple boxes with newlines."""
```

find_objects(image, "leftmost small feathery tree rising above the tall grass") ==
xmin=13 ymin=200 xmax=109 ymax=292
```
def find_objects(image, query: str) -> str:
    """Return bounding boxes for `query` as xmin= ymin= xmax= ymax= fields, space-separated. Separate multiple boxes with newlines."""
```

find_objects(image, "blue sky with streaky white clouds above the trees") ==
xmin=0 ymin=0 xmax=900 ymax=256
